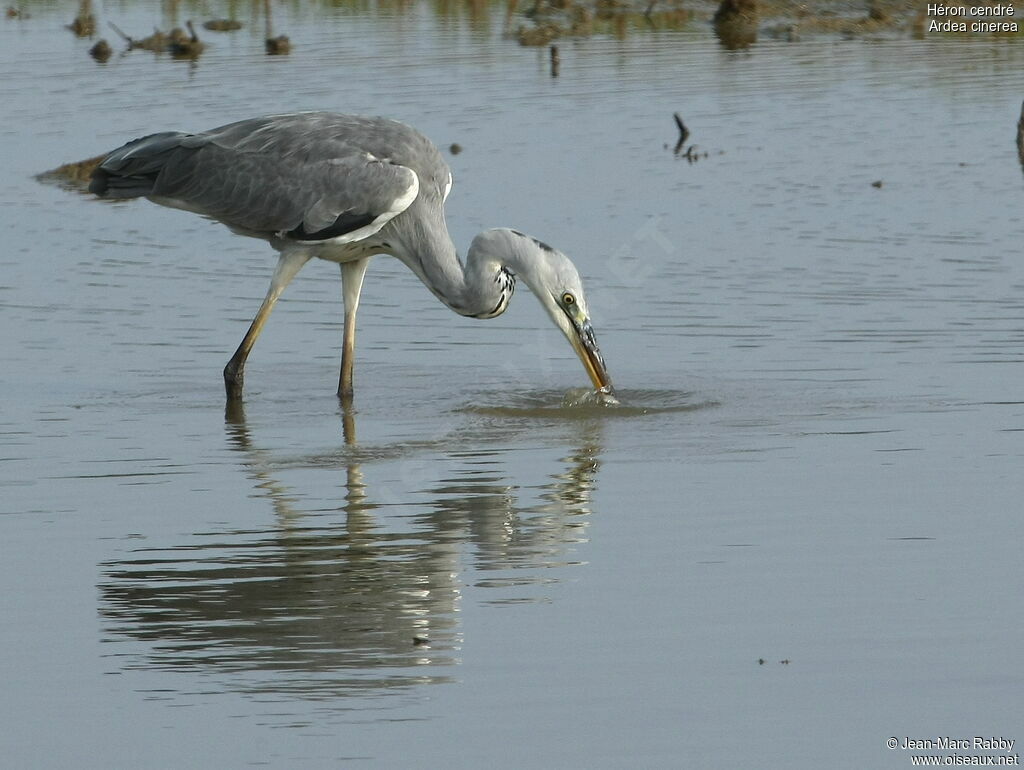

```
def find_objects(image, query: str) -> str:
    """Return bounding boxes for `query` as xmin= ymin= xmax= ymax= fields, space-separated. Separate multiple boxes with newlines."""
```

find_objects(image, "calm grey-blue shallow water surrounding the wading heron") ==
xmin=0 ymin=6 xmax=1024 ymax=768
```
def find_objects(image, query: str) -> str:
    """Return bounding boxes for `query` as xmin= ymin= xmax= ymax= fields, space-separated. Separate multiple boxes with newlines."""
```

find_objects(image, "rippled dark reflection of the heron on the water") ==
xmin=99 ymin=402 xmax=602 ymax=708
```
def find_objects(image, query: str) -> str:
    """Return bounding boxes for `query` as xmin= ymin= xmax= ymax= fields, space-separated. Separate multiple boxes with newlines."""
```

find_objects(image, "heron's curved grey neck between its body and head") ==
xmin=398 ymin=208 xmax=515 ymax=318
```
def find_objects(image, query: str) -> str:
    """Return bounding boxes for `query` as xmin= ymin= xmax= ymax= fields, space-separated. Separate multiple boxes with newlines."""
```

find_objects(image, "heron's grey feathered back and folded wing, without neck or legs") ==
xmin=90 ymin=114 xmax=436 ymax=241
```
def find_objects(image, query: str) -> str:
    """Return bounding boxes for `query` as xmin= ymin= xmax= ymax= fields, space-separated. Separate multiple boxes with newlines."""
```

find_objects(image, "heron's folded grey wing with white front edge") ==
xmin=150 ymin=134 xmax=419 ymax=243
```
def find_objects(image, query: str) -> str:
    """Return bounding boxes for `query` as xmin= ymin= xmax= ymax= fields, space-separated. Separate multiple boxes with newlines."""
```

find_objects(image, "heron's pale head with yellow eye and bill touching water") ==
xmin=470 ymin=227 xmax=611 ymax=393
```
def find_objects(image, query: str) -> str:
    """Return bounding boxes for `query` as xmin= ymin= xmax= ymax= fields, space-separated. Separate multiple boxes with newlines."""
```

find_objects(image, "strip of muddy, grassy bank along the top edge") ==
xmin=7 ymin=0 xmax=1024 ymax=61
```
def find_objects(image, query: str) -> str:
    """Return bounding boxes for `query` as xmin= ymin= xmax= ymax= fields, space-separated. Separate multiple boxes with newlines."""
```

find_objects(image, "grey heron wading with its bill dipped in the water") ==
xmin=89 ymin=113 xmax=611 ymax=398
